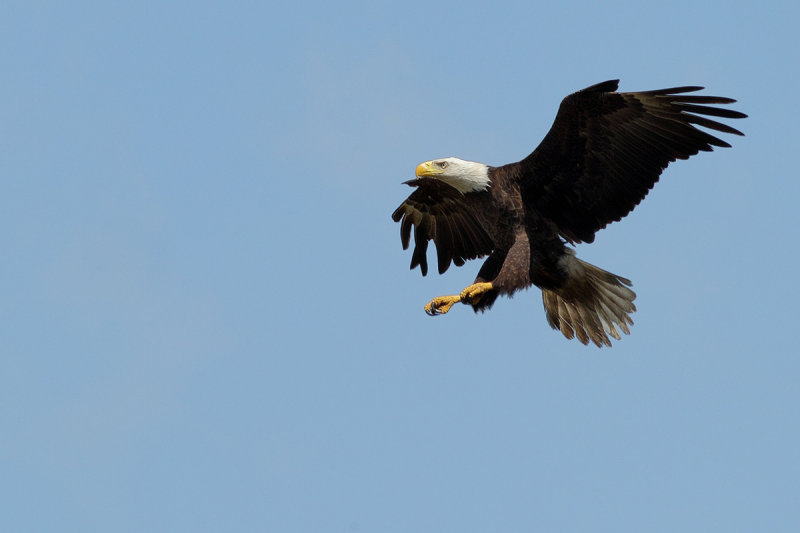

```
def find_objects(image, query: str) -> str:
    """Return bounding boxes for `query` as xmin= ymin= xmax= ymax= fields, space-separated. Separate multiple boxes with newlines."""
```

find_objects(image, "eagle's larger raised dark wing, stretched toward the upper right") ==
xmin=520 ymin=80 xmax=747 ymax=242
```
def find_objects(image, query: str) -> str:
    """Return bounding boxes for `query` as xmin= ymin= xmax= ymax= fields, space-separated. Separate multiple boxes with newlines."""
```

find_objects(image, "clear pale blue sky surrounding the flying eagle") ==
xmin=0 ymin=0 xmax=800 ymax=533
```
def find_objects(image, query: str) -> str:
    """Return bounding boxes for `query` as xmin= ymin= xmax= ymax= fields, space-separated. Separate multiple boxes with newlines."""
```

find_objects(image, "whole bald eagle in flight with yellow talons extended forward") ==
xmin=392 ymin=80 xmax=747 ymax=347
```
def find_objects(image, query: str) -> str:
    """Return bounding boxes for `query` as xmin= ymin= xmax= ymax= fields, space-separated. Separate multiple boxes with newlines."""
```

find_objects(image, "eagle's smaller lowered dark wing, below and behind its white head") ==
xmin=392 ymin=178 xmax=494 ymax=276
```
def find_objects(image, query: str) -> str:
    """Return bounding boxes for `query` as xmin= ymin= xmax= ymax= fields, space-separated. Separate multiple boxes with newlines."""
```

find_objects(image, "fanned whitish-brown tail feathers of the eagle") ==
xmin=542 ymin=250 xmax=636 ymax=346
